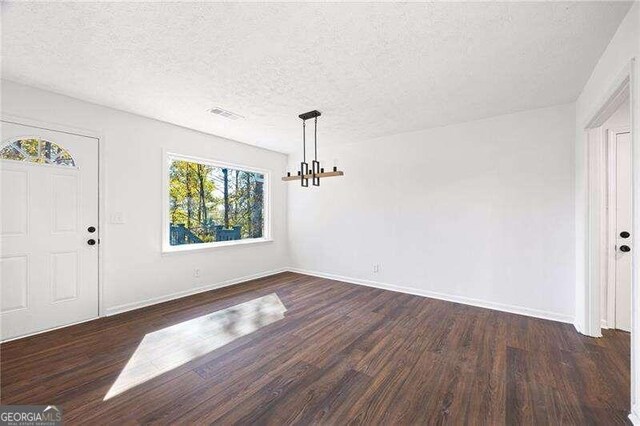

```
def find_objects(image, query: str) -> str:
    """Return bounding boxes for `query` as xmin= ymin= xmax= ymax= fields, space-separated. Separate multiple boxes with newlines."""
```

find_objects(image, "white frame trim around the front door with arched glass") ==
xmin=0 ymin=111 xmax=107 ymax=320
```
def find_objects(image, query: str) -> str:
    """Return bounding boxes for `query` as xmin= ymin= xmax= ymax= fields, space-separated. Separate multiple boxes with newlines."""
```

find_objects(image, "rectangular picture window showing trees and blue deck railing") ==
xmin=164 ymin=154 xmax=267 ymax=251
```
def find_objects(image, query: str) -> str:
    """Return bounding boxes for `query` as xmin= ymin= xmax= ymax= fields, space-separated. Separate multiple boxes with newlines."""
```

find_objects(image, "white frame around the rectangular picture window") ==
xmin=162 ymin=151 xmax=273 ymax=253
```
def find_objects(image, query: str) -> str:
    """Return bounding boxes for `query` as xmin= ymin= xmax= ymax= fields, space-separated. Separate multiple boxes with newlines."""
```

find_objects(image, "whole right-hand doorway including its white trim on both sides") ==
xmin=576 ymin=60 xmax=640 ymax=421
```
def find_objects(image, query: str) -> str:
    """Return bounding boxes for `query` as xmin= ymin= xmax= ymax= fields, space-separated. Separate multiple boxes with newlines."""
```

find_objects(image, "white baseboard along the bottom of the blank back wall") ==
xmin=289 ymin=268 xmax=575 ymax=324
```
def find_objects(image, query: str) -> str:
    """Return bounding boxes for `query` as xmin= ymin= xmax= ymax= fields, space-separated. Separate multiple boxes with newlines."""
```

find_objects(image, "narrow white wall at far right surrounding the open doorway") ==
xmin=575 ymin=2 xmax=640 ymax=424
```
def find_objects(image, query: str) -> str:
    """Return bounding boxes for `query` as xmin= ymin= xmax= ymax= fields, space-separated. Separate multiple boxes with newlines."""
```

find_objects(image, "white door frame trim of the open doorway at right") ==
xmin=576 ymin=59 xmax=640 ymax=421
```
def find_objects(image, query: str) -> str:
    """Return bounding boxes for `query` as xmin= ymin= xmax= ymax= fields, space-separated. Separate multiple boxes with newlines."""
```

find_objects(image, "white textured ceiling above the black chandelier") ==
xmin=2 ymin=2 xmax=630 ymax=152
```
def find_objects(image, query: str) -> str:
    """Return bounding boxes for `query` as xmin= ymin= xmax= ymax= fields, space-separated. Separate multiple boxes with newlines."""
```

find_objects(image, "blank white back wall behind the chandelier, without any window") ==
xmin=288 ymin=105 xmax=575 ymax=322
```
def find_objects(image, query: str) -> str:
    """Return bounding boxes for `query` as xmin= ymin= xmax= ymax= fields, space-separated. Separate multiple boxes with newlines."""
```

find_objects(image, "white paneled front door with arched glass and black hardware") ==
xmin=0 ymin=121 xmax=99 ymax=340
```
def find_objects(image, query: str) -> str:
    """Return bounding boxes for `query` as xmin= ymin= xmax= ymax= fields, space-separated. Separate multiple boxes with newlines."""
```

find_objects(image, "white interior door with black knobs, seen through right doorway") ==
xmin=613 ymin=131 xmax=633 ymax=331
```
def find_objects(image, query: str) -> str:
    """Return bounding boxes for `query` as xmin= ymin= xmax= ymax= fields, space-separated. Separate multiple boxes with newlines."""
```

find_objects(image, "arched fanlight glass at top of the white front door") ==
xmin=0 ymin=138 xmax=76 ymax=167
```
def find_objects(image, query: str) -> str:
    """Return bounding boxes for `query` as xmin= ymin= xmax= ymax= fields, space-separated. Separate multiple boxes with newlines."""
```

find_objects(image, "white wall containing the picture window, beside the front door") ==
xmin=2 ymin=81 xmax=288 ymax=313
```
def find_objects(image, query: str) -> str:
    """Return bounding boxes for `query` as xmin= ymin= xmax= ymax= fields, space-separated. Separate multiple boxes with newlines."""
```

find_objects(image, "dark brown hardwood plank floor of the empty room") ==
xmin=0 ymin=273 xmax=630 ymax=425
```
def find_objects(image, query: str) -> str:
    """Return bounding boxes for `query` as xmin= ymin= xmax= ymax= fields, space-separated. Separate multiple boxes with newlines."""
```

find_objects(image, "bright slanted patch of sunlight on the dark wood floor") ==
xmin=103 ymin=293 xmax=287 ymax=401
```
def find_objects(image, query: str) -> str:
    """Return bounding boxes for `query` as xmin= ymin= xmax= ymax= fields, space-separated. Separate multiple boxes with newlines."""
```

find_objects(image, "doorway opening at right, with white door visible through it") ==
xmin=582 ymin=72 xmax=636 ymax=337
